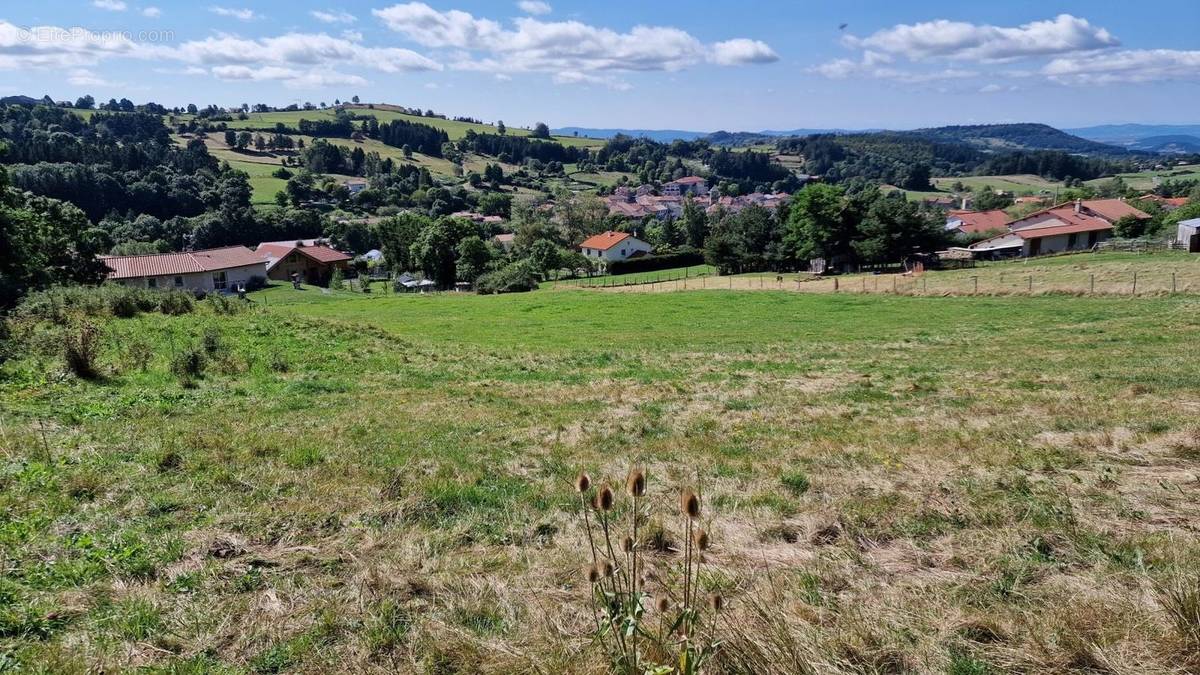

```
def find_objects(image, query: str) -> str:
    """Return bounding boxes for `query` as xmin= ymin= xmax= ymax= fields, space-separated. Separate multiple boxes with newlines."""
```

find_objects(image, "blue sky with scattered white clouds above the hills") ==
xmin=0 ymin=0 xmax=1200 ymax=131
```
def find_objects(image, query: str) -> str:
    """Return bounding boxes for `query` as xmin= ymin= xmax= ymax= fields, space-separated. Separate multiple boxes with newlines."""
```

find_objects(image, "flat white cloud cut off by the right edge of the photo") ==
xmin=1042 ymin=49 xmax=1200 ymax=84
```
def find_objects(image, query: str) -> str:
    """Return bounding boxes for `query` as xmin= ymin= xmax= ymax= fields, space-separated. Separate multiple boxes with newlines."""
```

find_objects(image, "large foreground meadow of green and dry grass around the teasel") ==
xmin=0 ymin=278 xmax=1200 ymax=674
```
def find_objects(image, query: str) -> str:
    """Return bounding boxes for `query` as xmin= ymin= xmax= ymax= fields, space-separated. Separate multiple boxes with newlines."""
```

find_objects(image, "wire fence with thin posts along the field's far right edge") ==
xmin=578 ymin=264 xmax=1200 ymax=297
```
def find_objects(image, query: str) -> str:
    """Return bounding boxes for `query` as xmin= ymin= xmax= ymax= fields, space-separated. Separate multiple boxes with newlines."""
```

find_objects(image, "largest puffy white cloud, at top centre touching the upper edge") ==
xmin=373 ymin=2 xmax=779 ymax=89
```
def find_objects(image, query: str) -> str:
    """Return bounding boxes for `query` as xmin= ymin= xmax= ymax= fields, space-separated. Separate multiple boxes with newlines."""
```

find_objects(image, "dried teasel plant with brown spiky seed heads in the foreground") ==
xmin=575 ymin=467 xmax=725 ymax=675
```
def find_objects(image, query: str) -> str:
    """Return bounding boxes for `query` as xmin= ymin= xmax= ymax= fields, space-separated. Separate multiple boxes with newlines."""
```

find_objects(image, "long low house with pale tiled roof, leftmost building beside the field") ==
xmin=100 ymin=246 xmax=266 ymax=292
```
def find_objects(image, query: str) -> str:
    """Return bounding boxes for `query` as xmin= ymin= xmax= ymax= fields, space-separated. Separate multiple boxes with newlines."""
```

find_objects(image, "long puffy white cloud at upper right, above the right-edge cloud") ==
xmin=845 ymin=14 xmax=1120 ymax=62
